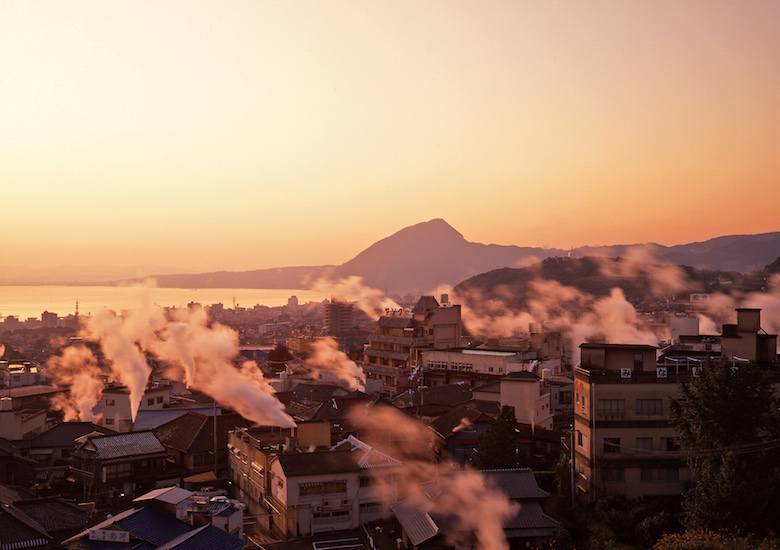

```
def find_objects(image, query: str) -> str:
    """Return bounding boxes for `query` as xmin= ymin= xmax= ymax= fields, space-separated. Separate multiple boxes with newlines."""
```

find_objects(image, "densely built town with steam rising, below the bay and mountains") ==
xmin=0 ymin=278 xmax=780 ymax=550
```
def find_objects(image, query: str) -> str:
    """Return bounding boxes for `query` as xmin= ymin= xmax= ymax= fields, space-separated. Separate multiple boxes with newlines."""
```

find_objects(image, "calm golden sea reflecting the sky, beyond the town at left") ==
xmin=0 ymin=286 xmax=330 ymax=321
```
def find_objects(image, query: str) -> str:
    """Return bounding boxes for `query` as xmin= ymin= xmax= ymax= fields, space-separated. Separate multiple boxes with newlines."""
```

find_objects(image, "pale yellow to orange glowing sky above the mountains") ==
xmin=0 ymin=0 xmax=780 ymax=272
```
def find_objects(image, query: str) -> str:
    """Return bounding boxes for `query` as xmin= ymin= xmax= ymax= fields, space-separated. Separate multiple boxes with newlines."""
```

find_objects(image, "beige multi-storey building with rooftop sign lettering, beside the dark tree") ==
xmin=574 ymin=344 xmax=690 ymax=501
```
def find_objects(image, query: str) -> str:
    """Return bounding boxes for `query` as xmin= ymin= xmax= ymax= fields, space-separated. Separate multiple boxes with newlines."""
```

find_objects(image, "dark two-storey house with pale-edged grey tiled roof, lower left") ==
xmin=70 ymin=432 xmax=170 ymax=512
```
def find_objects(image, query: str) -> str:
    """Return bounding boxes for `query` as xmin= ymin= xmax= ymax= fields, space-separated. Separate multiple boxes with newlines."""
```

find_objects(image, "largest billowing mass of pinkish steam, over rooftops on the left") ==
xmin=47 ymin=292 xmax=294 ymax=427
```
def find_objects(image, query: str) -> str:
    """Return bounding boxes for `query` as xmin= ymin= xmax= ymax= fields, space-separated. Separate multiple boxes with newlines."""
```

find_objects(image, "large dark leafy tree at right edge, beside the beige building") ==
xmin=671 ymin=360 xmax=780 ymax=533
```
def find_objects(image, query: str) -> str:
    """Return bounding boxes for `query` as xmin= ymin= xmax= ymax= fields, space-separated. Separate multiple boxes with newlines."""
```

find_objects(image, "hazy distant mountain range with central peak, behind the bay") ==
xmin=123 ymin=219 xmax=780 ymax=293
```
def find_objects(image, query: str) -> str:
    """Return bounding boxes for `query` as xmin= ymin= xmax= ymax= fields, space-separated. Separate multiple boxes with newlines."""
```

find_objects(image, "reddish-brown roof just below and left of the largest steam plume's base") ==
xmin=152 ymin=411 xmax=252 ymax=453
